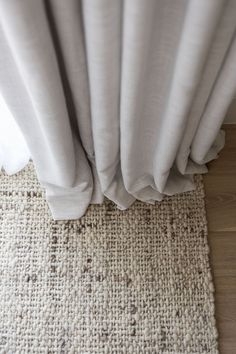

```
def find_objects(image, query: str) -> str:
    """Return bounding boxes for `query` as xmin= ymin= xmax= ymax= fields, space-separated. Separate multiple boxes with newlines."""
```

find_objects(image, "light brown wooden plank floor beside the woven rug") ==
xmin=204 ymin=125 xmax=236 ymax=354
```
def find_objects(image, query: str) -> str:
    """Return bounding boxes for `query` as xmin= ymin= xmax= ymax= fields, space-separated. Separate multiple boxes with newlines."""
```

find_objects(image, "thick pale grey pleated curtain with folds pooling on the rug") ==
xmin=0 ymin=0 xmax=236 ymax=219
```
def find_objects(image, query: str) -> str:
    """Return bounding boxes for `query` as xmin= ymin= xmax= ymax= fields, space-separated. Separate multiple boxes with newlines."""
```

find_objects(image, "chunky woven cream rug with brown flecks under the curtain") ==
xmin=0 ymin=164 xmax=218 ymax=354
